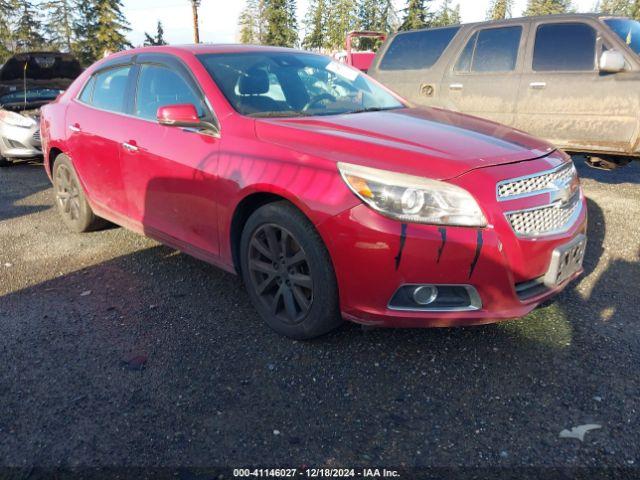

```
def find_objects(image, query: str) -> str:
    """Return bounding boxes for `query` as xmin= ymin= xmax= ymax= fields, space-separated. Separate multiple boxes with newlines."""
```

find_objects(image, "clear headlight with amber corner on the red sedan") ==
xmin=338 ymin=163 xmax=487 ymax=227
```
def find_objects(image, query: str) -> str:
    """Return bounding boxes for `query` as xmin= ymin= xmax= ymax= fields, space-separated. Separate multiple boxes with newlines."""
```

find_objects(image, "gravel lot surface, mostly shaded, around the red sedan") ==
xmin=0 ymin=158 xmax=640 ymax=474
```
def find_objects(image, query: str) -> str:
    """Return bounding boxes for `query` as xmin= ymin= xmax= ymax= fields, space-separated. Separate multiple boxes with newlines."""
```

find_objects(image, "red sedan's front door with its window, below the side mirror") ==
xmin=122 ymin=59 xmax=220 ymax=256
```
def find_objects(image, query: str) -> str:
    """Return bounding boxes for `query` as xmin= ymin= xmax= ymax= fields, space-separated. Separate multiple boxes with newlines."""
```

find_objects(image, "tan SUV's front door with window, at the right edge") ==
xmin=516 ymin=19 xmax=637 ymax=152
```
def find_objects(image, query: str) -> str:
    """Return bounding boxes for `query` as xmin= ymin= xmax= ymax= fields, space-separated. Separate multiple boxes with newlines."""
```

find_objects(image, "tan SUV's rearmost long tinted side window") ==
xmin=379 ymin=27 xmax=459 ymax=70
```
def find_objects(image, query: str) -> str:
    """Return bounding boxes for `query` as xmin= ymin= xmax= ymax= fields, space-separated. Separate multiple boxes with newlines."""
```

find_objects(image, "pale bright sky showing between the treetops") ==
xmin=124 ymin=0 xmax=596 ymax=45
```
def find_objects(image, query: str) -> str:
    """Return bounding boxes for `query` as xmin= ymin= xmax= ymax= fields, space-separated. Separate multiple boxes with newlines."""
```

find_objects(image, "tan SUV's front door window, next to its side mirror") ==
xmin=533 ymin=23 xmax=596 ymax=72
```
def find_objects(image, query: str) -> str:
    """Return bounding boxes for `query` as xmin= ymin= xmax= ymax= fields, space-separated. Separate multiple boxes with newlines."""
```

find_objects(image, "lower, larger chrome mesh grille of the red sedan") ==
xmin=506 ymin=191 xmax=582 ymax=237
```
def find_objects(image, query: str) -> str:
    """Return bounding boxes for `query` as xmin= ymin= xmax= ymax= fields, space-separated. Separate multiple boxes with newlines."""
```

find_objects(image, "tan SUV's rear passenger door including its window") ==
xmin=440 ymin=22 xmax=528 ymax=125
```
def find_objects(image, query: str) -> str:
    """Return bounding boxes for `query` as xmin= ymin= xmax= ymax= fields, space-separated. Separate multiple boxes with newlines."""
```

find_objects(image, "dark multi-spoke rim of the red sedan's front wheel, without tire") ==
xmin=248 ymin=224 xmax=313 ymax=325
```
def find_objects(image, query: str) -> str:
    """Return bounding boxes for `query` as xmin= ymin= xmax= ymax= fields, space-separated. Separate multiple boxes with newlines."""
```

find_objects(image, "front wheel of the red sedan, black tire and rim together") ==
xmin=240 ymin=201 xmax=342 ymax=340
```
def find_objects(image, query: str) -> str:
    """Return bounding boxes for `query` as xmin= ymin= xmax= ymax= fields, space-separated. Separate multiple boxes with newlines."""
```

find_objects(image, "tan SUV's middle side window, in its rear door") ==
xmin=455 ymin=26 xmax=522 ymax=72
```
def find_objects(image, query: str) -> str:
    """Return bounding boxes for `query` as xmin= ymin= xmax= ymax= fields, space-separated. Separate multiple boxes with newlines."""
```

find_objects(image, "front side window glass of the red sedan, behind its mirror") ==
xmin=134 ymin=64 xmax=205 ymax=120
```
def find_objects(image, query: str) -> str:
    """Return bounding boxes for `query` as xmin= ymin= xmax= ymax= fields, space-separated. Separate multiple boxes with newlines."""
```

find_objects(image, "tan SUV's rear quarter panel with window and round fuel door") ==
xmin=369 ymin=27 xmax=460 ymax=106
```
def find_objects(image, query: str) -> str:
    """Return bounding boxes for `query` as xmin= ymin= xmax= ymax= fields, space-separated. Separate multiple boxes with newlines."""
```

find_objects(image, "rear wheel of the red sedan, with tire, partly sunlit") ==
xmin=53 ymin=154 xmax=105 ymax=233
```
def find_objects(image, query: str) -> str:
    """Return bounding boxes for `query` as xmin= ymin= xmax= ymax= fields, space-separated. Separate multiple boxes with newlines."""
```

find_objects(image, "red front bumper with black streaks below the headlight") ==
xmin=318 ymin=157 xmax=587 ymax=327
